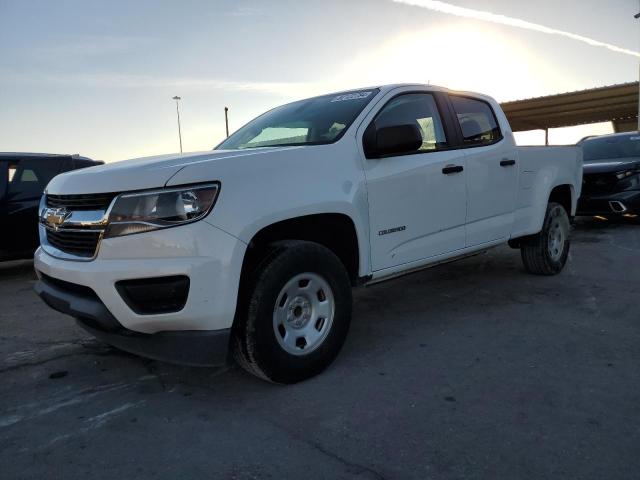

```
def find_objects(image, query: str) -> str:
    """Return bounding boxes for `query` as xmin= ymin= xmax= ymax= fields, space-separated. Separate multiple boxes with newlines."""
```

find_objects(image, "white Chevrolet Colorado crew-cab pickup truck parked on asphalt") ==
xmin=35 ymin=85 xmax=582 ymax=383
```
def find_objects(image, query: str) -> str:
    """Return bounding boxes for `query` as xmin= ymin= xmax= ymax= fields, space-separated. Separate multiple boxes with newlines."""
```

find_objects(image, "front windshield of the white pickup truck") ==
xmin=216 ymin=89 xmax=378 ymax=150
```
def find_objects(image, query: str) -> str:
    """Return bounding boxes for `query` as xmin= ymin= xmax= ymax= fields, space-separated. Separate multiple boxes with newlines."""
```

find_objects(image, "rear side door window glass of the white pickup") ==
xmin=449 ymin=95 xmax=502 ymax=147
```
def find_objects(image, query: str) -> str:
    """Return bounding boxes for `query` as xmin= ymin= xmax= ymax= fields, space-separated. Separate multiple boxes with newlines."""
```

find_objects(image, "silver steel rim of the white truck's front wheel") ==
xmin=273 ymin=273 xmax=335 ymax=355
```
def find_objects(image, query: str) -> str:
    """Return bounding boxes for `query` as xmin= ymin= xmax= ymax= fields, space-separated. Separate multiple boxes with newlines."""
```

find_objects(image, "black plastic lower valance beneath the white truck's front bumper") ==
xmin=35 ymin=276 xmax=231 ymax=366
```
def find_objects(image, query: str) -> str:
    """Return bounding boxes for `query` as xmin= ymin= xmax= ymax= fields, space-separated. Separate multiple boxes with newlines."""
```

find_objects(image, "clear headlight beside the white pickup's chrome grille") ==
xmin=104 ymin=183 xmax=220 ymax=237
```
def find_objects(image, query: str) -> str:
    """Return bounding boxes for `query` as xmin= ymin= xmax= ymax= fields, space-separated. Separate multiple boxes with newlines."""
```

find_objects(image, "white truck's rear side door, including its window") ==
xmin=449 ymin=95 xmax=519 ymax=247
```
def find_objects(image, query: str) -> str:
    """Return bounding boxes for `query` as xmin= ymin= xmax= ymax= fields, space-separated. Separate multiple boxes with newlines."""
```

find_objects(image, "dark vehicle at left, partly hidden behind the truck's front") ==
xmin=0 ymin=153 xmax=103 ymax=261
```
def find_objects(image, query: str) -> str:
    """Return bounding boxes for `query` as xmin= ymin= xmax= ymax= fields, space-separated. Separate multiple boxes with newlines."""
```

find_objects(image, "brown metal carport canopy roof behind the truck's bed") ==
xmin=502 ymin=82 xmax=638 ymax=132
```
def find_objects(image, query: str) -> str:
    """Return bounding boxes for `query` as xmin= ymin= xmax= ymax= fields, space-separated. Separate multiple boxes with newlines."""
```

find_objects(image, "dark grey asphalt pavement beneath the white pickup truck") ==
xmin=0 ymin=220 xmax=640 ymax=480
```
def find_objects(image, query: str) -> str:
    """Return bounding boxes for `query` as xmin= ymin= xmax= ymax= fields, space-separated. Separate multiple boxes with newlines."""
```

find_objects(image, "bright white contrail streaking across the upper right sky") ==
xmin=392 ymin=0 xmax=640 ymax=57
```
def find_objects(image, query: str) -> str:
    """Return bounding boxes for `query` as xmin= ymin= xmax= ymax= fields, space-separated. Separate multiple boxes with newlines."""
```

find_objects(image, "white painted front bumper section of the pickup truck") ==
xmin=34 ymin=220 xmax=246 ymax=344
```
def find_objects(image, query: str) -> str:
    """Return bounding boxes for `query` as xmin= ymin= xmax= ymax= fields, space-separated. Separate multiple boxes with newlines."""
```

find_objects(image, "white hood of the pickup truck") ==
xmin=47 ymin=147 xmax=300 ymax=195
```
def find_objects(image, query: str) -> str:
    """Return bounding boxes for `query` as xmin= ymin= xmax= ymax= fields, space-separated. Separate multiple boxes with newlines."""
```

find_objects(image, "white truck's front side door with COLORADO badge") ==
xmin=360 ymin=91 xmax=466 ymax=271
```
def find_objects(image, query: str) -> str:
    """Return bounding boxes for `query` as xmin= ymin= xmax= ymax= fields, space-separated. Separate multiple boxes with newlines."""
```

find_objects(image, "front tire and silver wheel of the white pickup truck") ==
xmin=233 ymin=241 xmax=352 ymax=384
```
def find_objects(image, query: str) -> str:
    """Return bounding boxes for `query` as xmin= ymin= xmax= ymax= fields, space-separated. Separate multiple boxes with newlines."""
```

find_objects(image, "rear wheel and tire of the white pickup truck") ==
xmin=520 ymin=202 xmax=571 ymax=275
